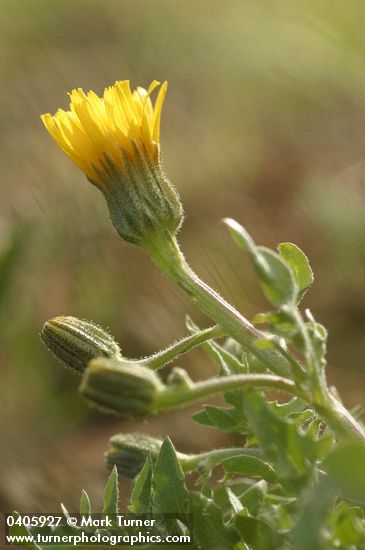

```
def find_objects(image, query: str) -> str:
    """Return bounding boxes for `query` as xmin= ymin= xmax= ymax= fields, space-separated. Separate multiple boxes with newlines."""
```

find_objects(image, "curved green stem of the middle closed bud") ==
xmin=155 ymin=374 xmax=302 ymax=412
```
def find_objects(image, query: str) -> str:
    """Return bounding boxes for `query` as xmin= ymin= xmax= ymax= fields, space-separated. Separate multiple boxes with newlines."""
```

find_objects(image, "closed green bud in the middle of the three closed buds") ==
xmin=80 ymin=358 xmax=165 ymax=418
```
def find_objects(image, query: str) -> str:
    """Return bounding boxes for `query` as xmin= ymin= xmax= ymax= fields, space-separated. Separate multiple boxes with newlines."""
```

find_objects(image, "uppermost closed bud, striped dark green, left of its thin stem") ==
xmin=40 ymin=316 xmax=120 ymax=373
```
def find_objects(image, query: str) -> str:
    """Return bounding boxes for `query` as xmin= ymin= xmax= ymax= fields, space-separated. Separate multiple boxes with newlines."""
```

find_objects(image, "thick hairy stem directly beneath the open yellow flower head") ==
xmin=145 ymin=239 xmax=290 ymax=375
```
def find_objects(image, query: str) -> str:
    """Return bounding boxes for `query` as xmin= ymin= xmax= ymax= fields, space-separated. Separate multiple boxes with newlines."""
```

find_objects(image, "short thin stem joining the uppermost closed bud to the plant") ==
xmin=140 ymin=325 xmax=225 ymax=370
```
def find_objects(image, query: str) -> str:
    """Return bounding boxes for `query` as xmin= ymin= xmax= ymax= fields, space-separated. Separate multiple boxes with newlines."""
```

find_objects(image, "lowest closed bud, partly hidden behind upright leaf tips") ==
xmin=105 ymin=433 xmax=162 ymax=479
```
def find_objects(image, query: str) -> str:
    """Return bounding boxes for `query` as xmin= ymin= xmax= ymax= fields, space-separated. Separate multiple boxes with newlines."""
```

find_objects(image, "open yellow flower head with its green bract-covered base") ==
xmin=42 ymin=80 xmax=183 ymax=246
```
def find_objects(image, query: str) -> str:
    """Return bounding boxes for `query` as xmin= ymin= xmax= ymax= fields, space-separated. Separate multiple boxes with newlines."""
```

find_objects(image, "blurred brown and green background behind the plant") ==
xmin=0 ymin=0 xmax=365 ymax=512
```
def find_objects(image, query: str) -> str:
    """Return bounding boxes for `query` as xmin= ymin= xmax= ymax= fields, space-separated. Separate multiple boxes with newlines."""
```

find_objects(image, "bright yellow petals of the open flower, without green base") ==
xmin=41 ymin=80 xmax=167 ymax=186
